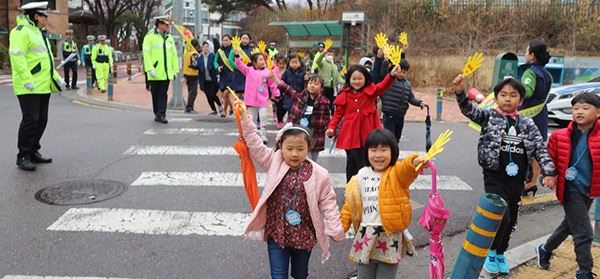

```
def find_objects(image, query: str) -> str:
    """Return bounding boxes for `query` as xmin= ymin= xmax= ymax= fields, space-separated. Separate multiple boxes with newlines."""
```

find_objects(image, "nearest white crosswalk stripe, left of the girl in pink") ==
xmin=48 ymin=208 xmax=250 ymax=236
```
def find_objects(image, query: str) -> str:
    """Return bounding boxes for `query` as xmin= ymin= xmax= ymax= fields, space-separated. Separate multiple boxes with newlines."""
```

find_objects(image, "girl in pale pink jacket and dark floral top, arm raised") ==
xmin=236 ymin=101 xmax=344 ymax=279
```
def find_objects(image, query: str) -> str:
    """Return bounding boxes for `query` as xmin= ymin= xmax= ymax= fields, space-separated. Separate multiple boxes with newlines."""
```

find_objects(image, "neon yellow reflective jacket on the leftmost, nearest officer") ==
xmin=8 ymin=15 xmax=60 ymax=95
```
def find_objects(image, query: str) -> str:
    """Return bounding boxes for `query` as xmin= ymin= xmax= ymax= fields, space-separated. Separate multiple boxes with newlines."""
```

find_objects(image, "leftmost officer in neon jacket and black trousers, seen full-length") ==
xmin=9 ymin=2 xmax=64 ymax=171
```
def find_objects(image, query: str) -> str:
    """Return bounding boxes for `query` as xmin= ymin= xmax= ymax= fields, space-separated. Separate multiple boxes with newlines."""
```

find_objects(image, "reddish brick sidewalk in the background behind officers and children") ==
xmin=72 ymin=74 xmax=467 ymax=122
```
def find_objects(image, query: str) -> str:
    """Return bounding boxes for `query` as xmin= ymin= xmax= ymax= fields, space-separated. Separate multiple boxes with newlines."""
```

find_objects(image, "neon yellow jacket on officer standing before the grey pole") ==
xmin=142 ymin=28 xmax=179 ymax=81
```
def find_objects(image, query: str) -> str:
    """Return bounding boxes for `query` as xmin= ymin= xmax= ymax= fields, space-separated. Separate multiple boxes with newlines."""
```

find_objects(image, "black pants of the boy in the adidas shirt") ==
xmin=483 ymin=174 xmax=524 ymax=254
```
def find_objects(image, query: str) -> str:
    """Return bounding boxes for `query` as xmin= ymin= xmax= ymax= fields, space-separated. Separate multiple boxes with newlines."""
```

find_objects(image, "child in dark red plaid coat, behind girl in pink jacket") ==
xmin=274 ymin=74 xmax=330 ymax=162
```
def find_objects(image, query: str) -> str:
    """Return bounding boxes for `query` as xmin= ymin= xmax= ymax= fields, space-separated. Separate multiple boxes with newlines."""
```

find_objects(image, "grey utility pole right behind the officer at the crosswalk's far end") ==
xmin=168 ymin=0 xmax=185 ymax=109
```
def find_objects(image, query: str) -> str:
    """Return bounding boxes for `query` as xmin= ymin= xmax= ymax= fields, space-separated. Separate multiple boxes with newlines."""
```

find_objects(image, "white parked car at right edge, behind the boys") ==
xmin=548 ymin=77 xmax=600 ymax=127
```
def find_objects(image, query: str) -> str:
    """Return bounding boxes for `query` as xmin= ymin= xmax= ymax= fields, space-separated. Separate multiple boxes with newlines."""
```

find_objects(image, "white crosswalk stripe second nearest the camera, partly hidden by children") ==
xmin=131 ymin=172 xmax=473 ymax=191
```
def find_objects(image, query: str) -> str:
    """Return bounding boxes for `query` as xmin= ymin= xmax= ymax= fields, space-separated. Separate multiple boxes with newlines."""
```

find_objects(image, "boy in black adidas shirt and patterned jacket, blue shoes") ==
xmin=453 ymin=75 xmax=555 ymax=274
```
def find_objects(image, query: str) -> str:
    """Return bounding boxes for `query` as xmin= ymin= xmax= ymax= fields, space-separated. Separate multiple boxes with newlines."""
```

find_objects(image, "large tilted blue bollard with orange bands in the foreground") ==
xmin=450 ymin=194 xmax=508 ymax=279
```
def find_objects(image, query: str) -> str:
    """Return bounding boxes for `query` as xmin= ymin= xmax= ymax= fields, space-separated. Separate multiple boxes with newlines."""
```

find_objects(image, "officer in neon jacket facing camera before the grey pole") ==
xmin=142 ymin=16 xmax=179 ymax=124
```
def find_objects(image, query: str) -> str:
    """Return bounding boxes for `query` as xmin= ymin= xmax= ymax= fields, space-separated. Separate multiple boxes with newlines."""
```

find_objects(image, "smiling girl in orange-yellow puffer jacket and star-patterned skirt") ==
xmin=340 ymin=129 xmax=424 ymax=279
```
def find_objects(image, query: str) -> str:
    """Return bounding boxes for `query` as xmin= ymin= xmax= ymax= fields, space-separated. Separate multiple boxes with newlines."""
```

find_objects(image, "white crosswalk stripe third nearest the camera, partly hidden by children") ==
xmin=123 ymin=143 xmax=424 ymax=158
